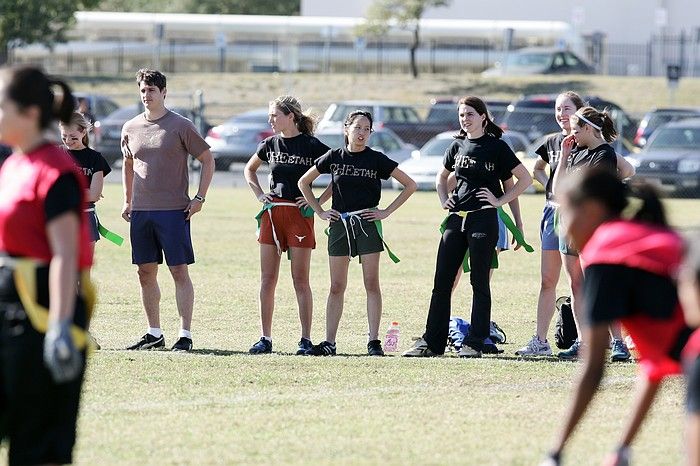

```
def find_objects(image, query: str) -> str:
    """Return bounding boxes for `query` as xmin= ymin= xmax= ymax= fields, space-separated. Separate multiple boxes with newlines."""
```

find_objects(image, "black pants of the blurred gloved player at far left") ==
xmin=0 ymin=294 xmax=85 ymax=464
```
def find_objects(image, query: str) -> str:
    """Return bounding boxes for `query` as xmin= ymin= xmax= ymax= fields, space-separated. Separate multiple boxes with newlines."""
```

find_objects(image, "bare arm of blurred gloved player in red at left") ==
xmin=46 ymin=211 xmax=80 ymax=321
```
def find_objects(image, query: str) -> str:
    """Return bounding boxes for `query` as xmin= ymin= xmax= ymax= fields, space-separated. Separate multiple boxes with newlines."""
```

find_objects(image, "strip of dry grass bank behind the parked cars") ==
xmin=72 ymin=70 xmax=700 ymax=123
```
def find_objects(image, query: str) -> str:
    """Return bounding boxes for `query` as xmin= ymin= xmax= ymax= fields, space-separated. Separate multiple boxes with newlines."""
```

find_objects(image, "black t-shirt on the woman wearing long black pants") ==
xmin=442 ymin=134 xmax=520 ymax=212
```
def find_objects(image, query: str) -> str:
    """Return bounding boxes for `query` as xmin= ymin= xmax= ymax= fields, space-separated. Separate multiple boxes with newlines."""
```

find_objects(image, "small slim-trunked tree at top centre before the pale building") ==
xmin=358 ymin=0 xmax=451 ymax=78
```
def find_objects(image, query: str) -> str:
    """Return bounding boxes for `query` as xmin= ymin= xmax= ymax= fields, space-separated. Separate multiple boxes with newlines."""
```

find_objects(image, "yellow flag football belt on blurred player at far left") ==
xmin=0 ymin=256 xmax=96 ymax=352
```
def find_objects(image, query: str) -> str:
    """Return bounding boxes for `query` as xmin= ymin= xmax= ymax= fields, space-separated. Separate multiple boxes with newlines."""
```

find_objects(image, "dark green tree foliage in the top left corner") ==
xmin=0 ymin=0 xmax=99 ymax=63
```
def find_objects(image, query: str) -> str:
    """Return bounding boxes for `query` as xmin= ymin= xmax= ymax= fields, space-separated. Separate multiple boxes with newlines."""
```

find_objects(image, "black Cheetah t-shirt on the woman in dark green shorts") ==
xmin=316 ymin=147 xmax=399 ymax=212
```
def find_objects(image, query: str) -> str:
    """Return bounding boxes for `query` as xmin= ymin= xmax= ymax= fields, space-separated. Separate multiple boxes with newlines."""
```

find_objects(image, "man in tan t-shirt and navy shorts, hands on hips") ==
xmin=121 ymin=69 xmax=214 ymax=351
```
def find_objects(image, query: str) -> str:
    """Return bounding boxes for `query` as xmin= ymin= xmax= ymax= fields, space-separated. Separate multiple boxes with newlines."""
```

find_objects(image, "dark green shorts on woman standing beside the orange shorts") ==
xmin=328 ymin=216 xmax=384 ymax=257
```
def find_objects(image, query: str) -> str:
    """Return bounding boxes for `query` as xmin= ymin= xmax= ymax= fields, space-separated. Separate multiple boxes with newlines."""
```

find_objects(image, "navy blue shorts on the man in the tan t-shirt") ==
xmin=129 ymin=210 xmax=194 ymax=266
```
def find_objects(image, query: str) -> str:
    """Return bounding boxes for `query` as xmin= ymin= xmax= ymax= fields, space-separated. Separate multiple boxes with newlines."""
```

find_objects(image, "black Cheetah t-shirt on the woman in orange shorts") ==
xmin=255 ymin=133 xmax=329 ymax=201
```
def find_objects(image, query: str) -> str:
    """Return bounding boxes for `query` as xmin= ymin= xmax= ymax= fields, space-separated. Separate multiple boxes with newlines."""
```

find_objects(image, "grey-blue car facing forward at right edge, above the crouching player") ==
xmin=628 ymin=118 xmax=700 ymax=196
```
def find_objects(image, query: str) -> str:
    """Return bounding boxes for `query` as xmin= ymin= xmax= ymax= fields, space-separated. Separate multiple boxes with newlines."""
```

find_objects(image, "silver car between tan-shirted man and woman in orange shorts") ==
xmin=206 ymin=107 xmax=275 ymax=170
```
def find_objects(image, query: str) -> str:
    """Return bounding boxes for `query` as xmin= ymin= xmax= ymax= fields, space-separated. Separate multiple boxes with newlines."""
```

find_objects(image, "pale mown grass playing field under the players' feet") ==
xmin=49 ymin=185 xmax=700 ymax=465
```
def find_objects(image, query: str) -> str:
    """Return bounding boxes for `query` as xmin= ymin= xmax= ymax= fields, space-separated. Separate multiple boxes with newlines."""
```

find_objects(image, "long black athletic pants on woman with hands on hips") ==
xmin=423 ymin=209 xmax=498 ymax=354
